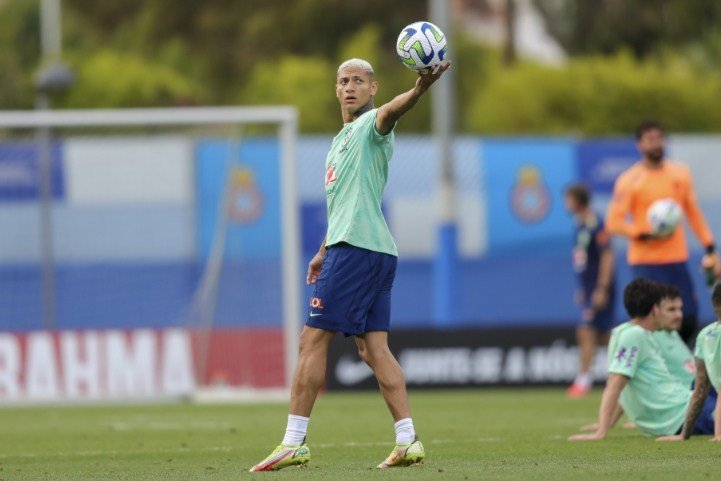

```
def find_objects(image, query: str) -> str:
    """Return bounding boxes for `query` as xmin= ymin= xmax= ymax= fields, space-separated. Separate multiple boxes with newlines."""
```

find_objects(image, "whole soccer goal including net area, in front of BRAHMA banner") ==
xmin=0 ymin=106 xmax=302 ymax=402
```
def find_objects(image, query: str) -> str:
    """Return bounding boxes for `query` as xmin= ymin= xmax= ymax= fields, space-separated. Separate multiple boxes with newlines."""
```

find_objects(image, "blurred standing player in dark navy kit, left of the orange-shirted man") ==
xmin=564 ymin=184 xmax=615 ymax=398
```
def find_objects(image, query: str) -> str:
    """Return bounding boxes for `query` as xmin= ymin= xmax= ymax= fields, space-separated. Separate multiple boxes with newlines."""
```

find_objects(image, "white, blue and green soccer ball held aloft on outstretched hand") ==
xmin=396 ymin=22 xmax=448 ymax=73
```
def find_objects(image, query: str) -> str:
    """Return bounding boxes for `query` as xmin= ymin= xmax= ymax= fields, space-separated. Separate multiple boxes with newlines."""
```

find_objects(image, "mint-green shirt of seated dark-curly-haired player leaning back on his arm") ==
xmin=608 ymin=322 xmax=691 ymax=436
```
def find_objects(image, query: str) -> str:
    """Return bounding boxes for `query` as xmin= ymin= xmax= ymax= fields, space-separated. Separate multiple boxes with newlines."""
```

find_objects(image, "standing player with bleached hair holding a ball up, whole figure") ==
xmin=250 ymin=59 xmax=451 ymax=471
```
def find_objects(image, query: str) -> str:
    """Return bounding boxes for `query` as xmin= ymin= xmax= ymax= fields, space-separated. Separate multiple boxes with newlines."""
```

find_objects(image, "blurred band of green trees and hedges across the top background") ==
xmin=0 ymin=0 xmax=721 ymax=134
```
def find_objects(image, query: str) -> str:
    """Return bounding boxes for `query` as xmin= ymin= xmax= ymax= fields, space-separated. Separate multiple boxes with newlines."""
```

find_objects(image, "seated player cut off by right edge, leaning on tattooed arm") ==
xmin=659 ymin=284 xmax=721 ymax=441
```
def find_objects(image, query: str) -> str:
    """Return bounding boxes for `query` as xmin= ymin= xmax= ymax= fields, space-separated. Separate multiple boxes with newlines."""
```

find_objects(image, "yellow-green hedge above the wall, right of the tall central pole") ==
xmin=464 ymin=53 xmax=721 ymax=135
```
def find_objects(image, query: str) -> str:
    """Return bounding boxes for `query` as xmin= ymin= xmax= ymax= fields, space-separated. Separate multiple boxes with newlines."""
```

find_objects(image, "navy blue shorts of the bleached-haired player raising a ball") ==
xmin=306 ymin=243 xmax=398 ymax=336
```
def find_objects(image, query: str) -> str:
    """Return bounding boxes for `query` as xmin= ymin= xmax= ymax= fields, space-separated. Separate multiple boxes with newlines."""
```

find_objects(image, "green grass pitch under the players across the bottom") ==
xmin=0 ymin=389 xmax=721 ymax=481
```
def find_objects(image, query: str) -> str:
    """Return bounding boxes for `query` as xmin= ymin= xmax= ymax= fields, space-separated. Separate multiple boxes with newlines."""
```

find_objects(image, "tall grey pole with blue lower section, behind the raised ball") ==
xmin=428 ymin=0 xmax=458 ymax=327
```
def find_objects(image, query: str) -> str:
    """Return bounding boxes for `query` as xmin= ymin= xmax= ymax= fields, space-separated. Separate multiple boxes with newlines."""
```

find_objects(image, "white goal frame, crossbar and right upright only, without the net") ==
xmin=0 ymin=106 xmax=301 ymax=400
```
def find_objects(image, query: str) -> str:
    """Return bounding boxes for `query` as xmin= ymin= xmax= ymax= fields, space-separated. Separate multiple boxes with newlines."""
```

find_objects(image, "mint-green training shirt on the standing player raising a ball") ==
xmin=325 ymin=109 xmax=398 ymax=256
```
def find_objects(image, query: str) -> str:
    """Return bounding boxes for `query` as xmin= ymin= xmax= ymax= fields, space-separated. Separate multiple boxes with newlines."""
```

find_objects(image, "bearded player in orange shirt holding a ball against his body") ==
xmin=606 ymin=121 xmax=721 ymax=343
